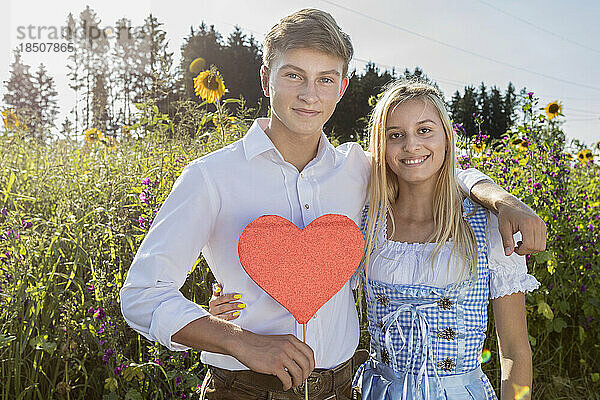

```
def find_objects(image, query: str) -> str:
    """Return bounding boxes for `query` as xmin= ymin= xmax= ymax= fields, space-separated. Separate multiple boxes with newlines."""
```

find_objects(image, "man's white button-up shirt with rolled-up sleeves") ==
xmin=121 ymin=119 xmax=489 ymax=370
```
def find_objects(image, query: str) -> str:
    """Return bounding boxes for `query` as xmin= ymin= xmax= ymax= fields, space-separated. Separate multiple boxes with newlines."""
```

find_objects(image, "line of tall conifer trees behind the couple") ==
xmin=4 ymin=6 xmax=519 ymax=143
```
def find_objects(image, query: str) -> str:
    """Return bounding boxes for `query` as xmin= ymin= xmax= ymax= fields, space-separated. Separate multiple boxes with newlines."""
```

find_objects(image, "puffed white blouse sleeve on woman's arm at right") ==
xmin=487 ymin=213 xmax=540 ymax=299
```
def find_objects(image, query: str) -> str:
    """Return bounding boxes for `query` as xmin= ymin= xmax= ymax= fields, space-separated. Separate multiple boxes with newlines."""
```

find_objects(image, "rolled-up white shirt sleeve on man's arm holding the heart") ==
xmin=121 ymin=160 xmax=219 ymax=350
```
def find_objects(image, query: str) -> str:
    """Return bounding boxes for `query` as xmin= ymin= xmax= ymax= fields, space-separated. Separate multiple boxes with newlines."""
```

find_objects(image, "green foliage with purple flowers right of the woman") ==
xmin=459 ymin=93 xmax=600 ymax=399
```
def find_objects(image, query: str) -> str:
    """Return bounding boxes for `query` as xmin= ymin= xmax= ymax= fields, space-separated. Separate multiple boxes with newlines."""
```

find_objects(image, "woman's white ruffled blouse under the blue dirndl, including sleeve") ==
xmin=367 ymin=213 xmax=540 ymax=298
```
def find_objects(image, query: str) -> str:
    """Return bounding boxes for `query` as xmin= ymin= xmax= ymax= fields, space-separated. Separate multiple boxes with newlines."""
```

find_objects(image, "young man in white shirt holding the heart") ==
xmin=121 ymin=9 xmax=545 ymax=400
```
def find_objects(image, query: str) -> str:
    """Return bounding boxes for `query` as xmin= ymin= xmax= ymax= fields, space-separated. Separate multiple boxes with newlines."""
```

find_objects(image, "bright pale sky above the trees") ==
xmin=0 ymin=0 xmax=600 ymax=144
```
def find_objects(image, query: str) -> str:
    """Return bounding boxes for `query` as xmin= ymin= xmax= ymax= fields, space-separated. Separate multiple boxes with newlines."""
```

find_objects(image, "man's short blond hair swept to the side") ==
xmin=263 ymin=8 xmax=354 ymax=76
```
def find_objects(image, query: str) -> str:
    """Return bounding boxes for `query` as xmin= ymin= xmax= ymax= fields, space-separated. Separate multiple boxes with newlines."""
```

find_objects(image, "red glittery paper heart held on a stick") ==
xmin=238 ymin=214 xmax=364 ymax=324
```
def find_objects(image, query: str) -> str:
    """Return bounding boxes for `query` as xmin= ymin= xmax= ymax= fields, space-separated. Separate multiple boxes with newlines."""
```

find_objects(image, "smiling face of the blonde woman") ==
xmin=385 ymin=99 xmax=446 ymax=188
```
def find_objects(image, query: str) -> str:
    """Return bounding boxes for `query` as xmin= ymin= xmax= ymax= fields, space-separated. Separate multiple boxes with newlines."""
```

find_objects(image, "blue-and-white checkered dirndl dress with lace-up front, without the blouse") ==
xmin=354 ymin=199 xmax=497 ymax=400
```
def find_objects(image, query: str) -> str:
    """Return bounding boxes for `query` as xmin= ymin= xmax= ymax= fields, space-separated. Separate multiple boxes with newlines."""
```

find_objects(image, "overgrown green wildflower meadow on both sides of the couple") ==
xmin=0 ymin=86 xmax=600 ymax=400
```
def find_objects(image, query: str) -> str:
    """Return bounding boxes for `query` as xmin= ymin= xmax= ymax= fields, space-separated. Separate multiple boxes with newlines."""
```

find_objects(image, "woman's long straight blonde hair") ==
xmin=364 ymin=79 xmax=478 ymax=285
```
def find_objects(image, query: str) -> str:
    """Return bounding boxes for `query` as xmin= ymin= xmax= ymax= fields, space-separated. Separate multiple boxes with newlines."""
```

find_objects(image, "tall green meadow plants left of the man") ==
xmin=0 ymin=99 xmax=248 ymax=399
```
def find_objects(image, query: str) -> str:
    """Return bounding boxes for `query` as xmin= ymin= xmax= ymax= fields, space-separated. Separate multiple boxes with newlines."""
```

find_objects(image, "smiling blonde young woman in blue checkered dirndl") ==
xmin=210 ymin=80 xmax=539 ymax=400
